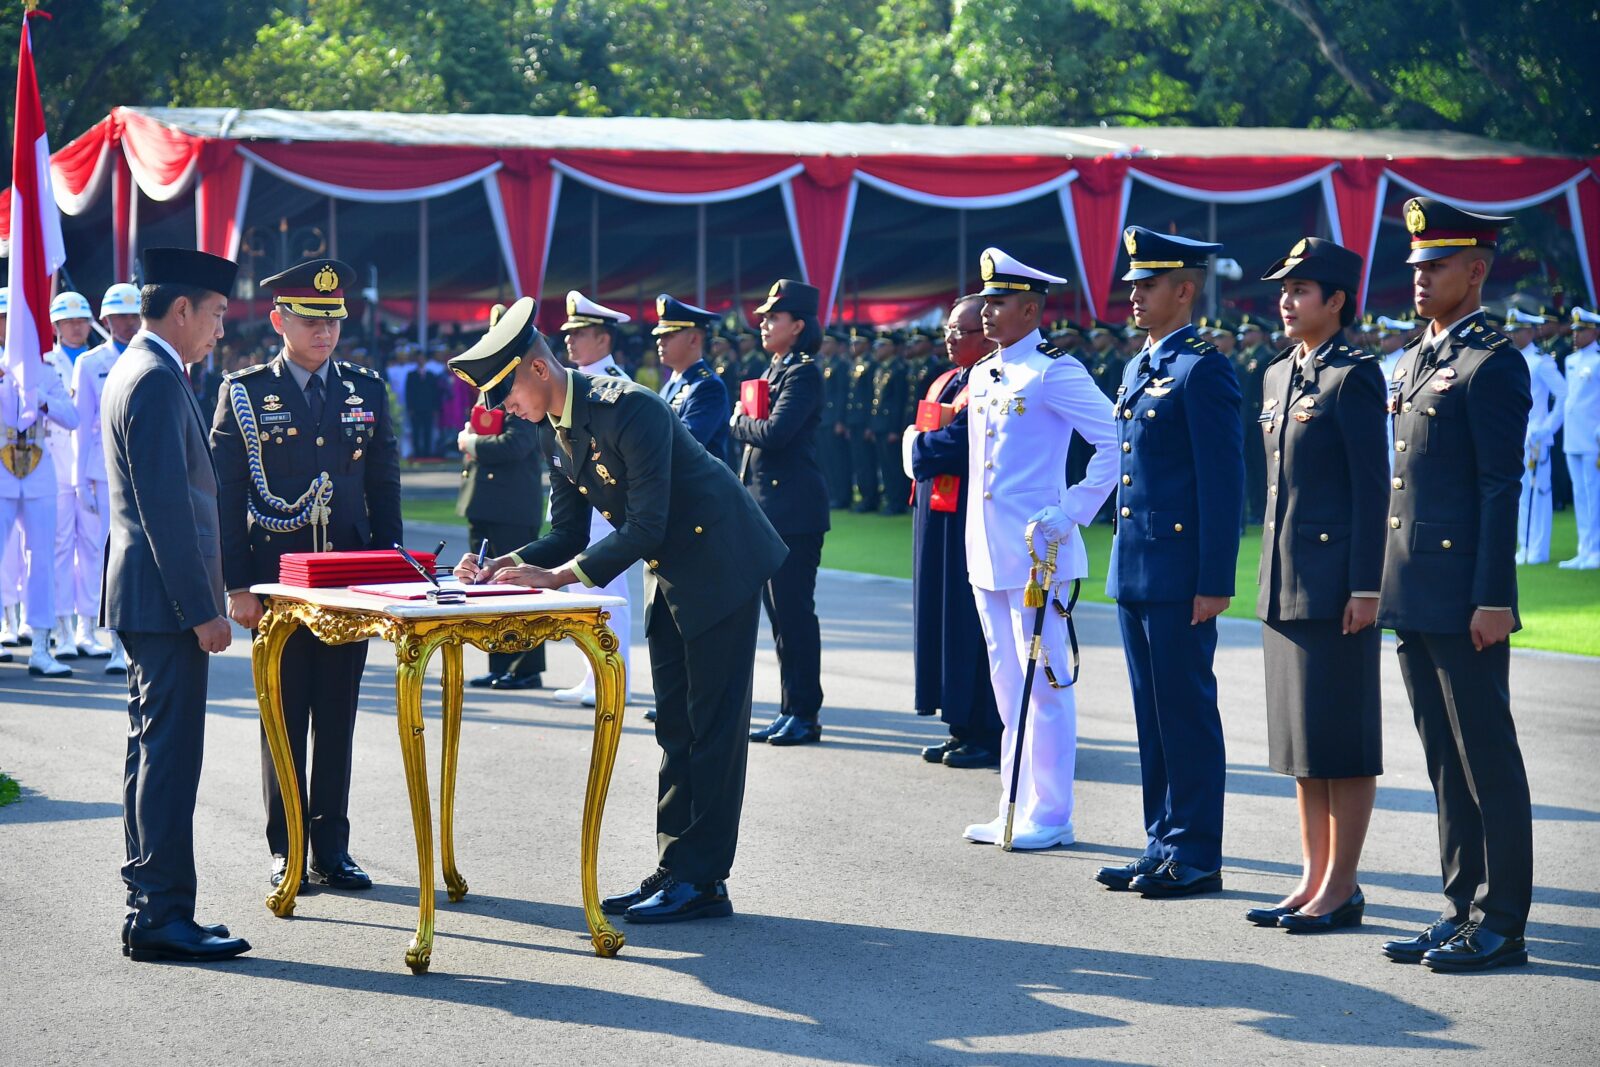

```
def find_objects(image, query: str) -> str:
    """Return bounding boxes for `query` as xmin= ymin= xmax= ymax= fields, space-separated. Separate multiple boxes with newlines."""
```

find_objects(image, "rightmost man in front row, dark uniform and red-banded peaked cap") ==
xmin=1378 ymin=197 xmax=1533 ymax=971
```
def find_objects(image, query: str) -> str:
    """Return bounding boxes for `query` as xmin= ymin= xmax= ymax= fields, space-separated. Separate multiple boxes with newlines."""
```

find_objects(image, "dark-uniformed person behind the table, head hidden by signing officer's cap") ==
xmin=456 ymin=404 xmax=544 ymax=689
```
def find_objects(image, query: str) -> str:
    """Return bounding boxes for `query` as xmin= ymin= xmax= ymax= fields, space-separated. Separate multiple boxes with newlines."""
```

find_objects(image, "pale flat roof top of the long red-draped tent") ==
xmin=128 ymin=107 xmax=1557 ymax=158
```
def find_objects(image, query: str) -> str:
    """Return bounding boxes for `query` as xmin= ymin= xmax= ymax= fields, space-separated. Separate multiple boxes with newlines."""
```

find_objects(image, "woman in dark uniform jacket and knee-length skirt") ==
xmin=1248 ymin=238 xmax=1389 ymax=931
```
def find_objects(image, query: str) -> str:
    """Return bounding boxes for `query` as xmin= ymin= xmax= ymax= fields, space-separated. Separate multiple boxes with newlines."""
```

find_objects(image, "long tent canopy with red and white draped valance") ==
xmin=0 ymin=107 xmax=1600 ymax=329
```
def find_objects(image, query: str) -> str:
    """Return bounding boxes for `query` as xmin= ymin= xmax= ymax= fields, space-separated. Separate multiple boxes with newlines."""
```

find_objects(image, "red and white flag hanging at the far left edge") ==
xmin=5 ymin=18 xmax=67 ymax=430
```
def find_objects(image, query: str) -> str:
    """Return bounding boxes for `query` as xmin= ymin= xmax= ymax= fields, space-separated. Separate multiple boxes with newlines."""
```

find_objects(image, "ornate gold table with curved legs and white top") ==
xmin=251 ymin=584 xmax=627 ymax=974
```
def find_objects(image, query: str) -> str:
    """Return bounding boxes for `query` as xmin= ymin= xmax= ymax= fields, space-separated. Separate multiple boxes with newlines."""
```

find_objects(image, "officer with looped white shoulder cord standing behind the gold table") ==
xmin=211 ymin=259 xmax=403 ymax=889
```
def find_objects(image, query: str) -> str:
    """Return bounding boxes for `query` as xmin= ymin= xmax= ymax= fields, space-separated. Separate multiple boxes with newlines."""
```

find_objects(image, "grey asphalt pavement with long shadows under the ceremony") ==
xmin=0 ymin=563 xmax=1600 ymax=1067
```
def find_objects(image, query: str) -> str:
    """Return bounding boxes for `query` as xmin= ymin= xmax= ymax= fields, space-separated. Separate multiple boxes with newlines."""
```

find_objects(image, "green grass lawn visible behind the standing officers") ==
xmin=405 ymin=501 xmax=1600 ymax=656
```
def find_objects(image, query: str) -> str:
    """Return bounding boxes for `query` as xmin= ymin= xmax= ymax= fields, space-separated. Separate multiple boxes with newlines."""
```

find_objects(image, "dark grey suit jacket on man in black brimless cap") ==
xmin=101 ymin=336 xmax=222 ymax=633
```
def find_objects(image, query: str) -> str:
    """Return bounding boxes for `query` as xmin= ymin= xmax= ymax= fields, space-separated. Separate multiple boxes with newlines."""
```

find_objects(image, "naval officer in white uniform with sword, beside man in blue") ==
xmin=965 ymin=248 xmax=1117 ymax=849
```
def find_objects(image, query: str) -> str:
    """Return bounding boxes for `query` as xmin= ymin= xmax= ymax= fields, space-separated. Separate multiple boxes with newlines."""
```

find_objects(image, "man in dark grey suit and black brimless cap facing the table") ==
xmin=101 ymin=248 xmax=250 ymax=961
